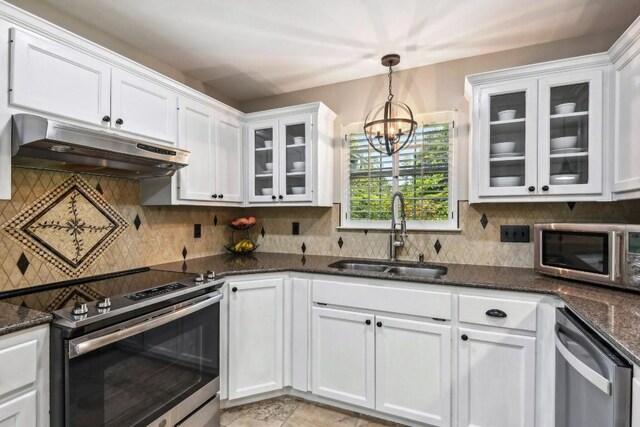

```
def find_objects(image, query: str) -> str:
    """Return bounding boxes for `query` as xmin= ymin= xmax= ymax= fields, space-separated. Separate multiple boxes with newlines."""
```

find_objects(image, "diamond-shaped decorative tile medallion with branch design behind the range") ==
xmin=2 ymin=175 xmax=128 ymax=277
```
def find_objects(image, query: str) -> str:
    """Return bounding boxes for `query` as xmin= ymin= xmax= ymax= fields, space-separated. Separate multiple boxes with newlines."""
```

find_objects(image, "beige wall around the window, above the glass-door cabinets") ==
xmin=240 ymin=33 xmax=620 ymax=202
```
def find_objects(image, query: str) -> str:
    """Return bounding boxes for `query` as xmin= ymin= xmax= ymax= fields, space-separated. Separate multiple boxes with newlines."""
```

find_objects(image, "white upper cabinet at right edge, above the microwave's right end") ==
xmin=609 ymin=18 xmax=640 ymax=199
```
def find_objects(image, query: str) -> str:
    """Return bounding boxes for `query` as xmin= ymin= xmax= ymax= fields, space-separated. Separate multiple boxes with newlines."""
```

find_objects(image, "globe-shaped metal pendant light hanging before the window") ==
xmin=364 ymin=54 xmax=418 ymax=156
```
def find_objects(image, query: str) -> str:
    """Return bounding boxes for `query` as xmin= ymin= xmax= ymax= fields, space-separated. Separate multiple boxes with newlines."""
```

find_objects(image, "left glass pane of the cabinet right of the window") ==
xmin=488 ymin=91 xmax=526 ymax=187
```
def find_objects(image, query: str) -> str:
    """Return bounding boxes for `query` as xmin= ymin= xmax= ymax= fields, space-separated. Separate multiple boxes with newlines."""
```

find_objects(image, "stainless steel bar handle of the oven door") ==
xmin=69 ymin=292 xmax=223 ymax=359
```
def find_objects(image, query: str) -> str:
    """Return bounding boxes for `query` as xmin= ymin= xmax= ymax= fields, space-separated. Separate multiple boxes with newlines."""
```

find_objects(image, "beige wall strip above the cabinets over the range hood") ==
xmin=6 ymin=0 xmax=239 ymax=108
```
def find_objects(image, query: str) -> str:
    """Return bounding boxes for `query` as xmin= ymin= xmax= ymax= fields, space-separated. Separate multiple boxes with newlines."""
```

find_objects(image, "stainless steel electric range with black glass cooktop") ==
xmin=4 ymin=269 xmax=224 ymax=427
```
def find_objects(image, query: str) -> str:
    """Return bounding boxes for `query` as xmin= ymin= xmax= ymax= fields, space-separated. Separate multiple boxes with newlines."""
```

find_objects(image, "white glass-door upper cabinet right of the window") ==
xmin=466 ymin=54 xmax=610 ymax=203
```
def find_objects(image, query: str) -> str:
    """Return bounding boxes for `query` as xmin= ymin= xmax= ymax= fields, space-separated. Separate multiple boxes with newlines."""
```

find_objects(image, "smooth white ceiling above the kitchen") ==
xmin=45 ymin=0 xmax=640 ymax=101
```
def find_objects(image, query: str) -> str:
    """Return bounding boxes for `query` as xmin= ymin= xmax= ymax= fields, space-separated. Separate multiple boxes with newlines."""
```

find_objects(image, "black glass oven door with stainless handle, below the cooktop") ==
xmin=65 ymin=292 xmax=222 ymax=427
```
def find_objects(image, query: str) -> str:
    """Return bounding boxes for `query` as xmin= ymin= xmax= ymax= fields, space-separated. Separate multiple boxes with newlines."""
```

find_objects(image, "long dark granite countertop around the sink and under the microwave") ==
xmin=152 ymin=252 xmax=640 ymax=365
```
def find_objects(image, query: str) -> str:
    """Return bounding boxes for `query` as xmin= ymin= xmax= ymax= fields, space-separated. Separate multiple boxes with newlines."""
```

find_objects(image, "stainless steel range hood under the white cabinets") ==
xmin=11 ymin=114 xmax=190 ymax=179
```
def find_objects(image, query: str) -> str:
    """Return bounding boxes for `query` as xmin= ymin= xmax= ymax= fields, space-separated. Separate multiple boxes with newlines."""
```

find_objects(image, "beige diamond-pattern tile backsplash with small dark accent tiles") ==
xmin=0 ymin=168 xmax=640 ymax=291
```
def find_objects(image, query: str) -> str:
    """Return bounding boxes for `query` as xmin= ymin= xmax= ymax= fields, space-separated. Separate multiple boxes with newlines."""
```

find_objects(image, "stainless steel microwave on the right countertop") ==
xmin=533 ymin=223 xmax=640 ymax=290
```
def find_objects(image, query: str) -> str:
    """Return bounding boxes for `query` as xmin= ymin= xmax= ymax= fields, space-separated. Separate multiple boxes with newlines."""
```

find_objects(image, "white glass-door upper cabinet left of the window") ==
xmin=246 ymin=103 xmax=336 ymax=206
